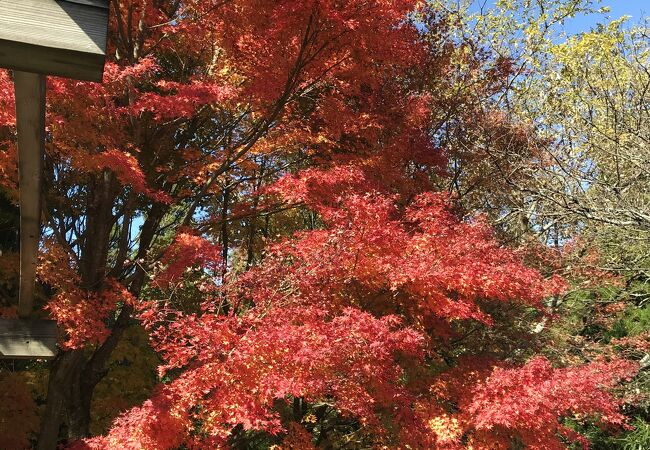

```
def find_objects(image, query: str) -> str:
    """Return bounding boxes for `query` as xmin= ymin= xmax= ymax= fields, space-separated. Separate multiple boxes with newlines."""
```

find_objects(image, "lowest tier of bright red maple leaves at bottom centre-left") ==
xmin=90 ymin=307 xmax=423 ymax=449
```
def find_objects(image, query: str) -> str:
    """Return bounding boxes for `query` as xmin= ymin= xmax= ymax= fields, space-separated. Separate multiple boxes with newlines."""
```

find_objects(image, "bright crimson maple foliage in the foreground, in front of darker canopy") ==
xmin=74 ymin=173 xmax=636 ymax=449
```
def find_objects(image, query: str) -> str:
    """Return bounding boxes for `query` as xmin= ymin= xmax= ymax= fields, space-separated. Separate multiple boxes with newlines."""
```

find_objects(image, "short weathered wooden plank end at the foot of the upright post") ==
xmin=0 ymin=319 xmax=58 ymax=359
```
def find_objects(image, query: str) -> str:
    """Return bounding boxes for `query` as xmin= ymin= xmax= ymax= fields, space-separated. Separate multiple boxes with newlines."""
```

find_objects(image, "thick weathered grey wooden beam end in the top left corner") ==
xmin=0 ymin=0 xmax=108 ymax=81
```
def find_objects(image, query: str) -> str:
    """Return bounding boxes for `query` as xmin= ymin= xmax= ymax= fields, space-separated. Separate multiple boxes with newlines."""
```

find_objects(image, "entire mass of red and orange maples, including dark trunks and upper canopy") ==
xmin=0 ymin=0 xmax=638 ymax=450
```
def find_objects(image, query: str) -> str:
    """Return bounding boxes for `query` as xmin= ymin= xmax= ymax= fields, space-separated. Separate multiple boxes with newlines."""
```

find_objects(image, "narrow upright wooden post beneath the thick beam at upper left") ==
xmin=14 ymin=72 xmax=45 ymax=317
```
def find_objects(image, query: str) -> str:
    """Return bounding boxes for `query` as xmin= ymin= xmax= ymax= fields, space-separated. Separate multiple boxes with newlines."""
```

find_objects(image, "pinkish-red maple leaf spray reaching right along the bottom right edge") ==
xmin=412 ymin=357 xmax=638 ymax=450
